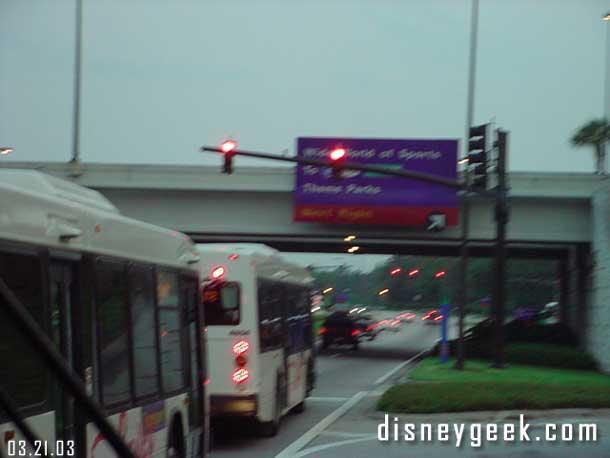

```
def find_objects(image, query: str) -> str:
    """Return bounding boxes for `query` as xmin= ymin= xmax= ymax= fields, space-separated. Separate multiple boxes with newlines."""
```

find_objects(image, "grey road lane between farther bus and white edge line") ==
xmin=211 ymin=317 xmax=440 ymax=458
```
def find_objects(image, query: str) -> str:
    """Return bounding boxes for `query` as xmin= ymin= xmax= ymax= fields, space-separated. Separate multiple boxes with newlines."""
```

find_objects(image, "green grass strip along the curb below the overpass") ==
xmin=377 ymin=358 xmax=610 ymax=413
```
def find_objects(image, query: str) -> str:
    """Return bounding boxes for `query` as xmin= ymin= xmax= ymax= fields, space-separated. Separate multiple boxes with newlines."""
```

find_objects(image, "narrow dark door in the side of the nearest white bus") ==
xmin=49 ymin=260 xmax=76 ymax=440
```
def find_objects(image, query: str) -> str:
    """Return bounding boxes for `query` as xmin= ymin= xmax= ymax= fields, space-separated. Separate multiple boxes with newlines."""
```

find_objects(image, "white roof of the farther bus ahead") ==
xmin=197 ymin=243 xmax=313 ymax=285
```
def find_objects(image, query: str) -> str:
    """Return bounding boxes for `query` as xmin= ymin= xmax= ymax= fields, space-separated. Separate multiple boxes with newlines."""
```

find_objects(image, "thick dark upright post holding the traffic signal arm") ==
xmin=492 ymin=129 xmax=509 ymax=369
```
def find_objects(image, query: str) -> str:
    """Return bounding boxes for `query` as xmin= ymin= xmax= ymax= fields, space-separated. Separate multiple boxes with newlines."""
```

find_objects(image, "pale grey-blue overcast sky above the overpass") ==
xmin=0 ymin=0 xmax=610 ymax=171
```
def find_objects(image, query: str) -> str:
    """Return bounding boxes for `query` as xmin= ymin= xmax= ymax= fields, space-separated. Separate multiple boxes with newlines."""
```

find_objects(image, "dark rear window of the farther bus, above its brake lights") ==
xmin=203 ymin=282 xmax=240 ymax=326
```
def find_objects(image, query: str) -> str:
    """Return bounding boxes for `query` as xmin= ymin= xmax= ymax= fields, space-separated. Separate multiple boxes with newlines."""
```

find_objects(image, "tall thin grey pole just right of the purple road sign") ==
xmin=455 ymin=0 xmax=479 ymax=370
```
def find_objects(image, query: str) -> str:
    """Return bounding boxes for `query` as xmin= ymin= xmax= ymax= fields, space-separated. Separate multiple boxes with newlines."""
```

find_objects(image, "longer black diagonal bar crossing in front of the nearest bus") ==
xmin=0 ymin=278 xmax=136 ymax=458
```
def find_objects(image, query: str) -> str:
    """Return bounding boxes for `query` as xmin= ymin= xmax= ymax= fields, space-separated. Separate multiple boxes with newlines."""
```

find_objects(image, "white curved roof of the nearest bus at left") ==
xmin=0 ymin=169 xmax=198 ymax=266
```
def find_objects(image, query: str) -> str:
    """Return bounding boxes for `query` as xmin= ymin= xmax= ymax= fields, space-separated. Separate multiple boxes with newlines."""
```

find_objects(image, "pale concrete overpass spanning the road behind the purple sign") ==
xmin=2 ymin=162 xmax=610 ymax=371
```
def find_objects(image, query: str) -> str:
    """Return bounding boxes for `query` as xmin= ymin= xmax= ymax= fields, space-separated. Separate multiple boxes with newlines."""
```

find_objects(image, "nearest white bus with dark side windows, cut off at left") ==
xmin=0 ymin=170 xmax=207 ymax=458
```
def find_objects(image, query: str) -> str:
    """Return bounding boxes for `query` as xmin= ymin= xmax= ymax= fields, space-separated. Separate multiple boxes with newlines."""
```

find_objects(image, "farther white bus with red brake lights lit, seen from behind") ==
xmin=197 ymin=244 xmax=314 ymax=436
